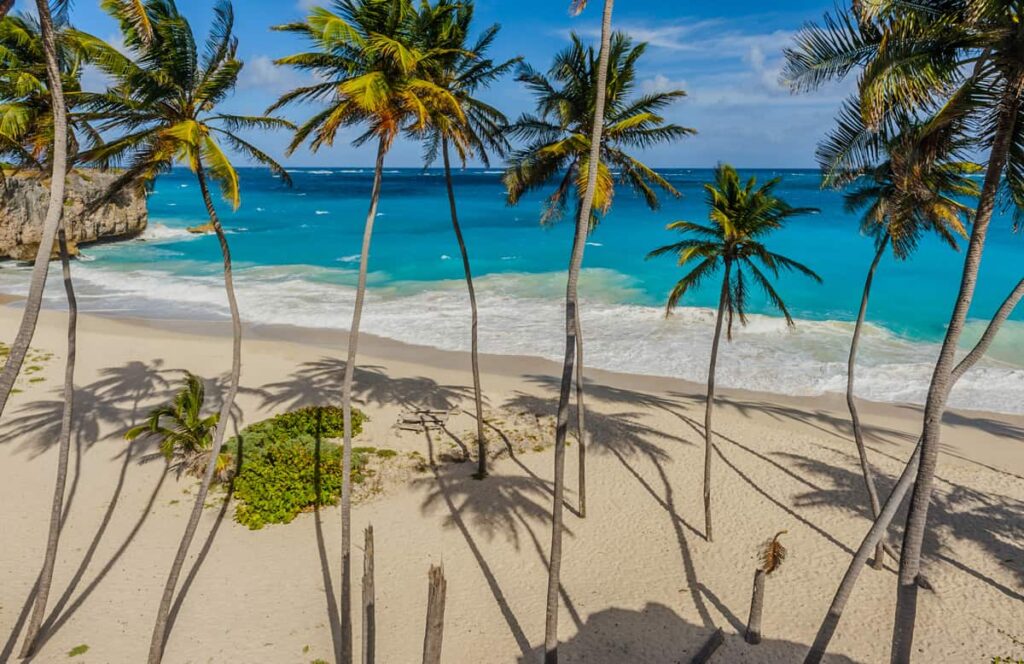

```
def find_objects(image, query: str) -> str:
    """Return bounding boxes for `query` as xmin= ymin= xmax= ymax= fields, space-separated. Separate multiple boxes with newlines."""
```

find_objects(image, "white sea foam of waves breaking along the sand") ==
xmin=14 ymin=264 xmax=1024 ymax=413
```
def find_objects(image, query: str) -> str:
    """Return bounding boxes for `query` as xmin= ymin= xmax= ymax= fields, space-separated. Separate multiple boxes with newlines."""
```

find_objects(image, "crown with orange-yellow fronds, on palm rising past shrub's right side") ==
xmin=269 ymin=0 xmax=464 ymax=152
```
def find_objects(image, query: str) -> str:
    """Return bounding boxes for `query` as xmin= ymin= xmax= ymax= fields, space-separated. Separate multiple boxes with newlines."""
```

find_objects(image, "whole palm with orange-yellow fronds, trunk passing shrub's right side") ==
xmin=271 ymin=0 xmax=464 ymax=664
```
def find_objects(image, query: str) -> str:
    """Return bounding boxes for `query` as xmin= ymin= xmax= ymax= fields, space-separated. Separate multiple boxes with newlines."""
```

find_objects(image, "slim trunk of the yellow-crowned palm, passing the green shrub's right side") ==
xmin=341 ymin=138 xmax=387 ymax=664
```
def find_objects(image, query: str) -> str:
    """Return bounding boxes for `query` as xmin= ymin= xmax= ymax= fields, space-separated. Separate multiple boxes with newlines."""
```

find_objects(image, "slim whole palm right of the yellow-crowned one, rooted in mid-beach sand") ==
xmin=411 ymin=0 xmax=520 ymax=479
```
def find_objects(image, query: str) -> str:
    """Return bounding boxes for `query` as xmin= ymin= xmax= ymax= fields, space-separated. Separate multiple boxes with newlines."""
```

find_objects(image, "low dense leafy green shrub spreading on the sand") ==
xmin=227 ymin=407 xmax=367 ymax=530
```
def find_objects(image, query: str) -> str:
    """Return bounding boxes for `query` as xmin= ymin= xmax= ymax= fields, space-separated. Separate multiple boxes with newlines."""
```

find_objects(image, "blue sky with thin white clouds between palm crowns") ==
xmin=59 ymin=0 xmax=844 ymax=167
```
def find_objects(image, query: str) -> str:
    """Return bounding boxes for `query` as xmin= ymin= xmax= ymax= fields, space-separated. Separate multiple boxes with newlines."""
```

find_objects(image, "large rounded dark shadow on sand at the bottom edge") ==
xmin=518 ymin=603 xmax=858 ymax=664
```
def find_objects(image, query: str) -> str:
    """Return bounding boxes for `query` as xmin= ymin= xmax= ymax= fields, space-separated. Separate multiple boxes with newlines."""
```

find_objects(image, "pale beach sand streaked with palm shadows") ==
xmin=0 ymin=304 xmax=1024 ymax=664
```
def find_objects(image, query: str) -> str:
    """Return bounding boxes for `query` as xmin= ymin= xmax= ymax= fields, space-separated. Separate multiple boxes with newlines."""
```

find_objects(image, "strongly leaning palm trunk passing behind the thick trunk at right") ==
xmin=804 ymin=279 xmax=1024 ymax=664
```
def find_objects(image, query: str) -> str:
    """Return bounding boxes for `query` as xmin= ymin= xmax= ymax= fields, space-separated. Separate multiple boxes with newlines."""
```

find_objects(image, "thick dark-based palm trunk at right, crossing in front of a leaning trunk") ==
xmin=891 ymin=94 xmax=1020 ymax=664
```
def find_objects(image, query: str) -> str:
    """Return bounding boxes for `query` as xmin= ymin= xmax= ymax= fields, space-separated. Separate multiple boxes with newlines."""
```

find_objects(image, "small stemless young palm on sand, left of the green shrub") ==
xmin=125 ymin=373 xmax=230 ymax=482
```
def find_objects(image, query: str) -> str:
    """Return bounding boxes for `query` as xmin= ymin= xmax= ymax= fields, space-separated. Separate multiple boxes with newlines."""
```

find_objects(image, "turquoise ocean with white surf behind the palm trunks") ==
xmin=0 ymin=168 xmax=1024 ymax=413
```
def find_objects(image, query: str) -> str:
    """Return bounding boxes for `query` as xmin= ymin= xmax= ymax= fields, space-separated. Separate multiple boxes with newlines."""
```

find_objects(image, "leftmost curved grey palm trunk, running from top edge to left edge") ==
xmin=0 ymin=0 xmax=68 ymax=416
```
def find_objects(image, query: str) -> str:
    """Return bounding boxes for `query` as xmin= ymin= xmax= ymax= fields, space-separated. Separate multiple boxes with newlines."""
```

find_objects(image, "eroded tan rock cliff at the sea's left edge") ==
xmin=0 ymin=170 xmax=148 ymax=260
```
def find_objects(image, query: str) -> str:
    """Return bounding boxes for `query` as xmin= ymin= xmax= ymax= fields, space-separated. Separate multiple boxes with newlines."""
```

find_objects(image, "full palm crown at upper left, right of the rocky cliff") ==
xmin=76 ymin=0 xmax=292 ymax=201
